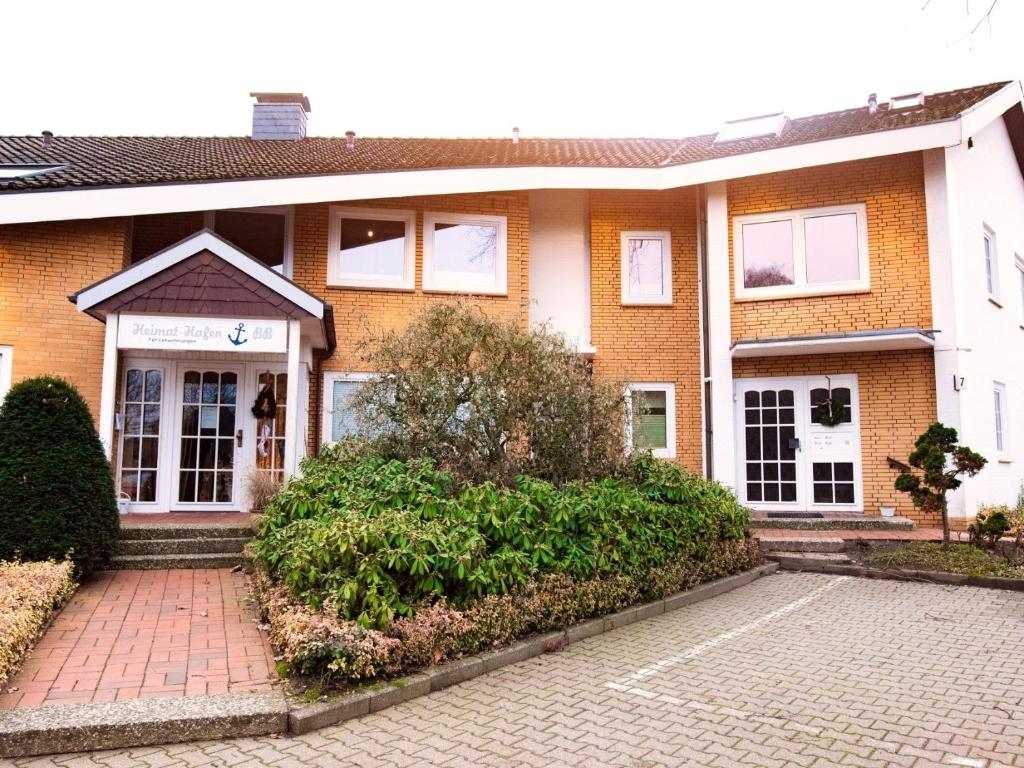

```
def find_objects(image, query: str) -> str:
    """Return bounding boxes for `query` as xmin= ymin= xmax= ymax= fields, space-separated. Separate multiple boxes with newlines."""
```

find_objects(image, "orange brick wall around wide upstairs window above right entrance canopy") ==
xmin=728 ymin=153 xmax=932 ymax=340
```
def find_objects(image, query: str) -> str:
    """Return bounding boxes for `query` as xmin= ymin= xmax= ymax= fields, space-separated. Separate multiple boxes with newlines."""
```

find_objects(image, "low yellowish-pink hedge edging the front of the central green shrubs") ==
xmin=254 ymin=539 xmax=761 ymax=684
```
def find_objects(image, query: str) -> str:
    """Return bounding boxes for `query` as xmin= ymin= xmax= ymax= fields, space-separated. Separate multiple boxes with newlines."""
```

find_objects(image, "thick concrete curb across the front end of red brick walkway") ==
xmin=0 ymin=691 xmax=288 ymax=758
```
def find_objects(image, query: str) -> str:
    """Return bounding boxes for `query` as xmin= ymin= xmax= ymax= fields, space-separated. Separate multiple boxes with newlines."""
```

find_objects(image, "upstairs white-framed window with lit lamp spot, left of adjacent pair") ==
xmin=328 ymin=206 xmax=416 ymax=291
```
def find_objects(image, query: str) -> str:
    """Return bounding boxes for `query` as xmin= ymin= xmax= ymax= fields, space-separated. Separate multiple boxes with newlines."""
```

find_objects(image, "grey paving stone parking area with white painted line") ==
xmin=17 ymin=573 xmax=1024 ymax=768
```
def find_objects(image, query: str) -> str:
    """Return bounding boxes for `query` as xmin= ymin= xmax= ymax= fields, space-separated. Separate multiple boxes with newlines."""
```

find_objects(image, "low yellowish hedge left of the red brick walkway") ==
xmin=0 ymin=560 xmax=76 ymax=684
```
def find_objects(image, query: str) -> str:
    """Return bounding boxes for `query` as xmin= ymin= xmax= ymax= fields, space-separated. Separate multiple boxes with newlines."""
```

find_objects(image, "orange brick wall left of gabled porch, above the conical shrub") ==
xmin=0 ymin=219 xmax=128 ymax=419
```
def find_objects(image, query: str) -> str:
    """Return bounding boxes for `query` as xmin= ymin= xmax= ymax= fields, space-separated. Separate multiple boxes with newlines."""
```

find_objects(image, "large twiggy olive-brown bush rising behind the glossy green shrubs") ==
xmin=352 ymin=303 xmax=626 ymax=485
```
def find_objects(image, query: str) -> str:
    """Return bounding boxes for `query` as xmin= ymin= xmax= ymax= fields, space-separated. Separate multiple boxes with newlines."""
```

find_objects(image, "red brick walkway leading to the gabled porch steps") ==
xmin=0 ymin=569 xmax=273 ymax=708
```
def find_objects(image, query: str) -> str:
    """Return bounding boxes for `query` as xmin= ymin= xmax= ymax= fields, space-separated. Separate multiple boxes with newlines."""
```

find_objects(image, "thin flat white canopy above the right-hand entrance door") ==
xmin=732 ymin=328 xmax=936 ymax=357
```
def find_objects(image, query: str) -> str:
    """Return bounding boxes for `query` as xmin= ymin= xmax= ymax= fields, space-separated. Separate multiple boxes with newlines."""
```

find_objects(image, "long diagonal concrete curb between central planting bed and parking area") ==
xmin=288 ymin=563 xmax=778 ymax=733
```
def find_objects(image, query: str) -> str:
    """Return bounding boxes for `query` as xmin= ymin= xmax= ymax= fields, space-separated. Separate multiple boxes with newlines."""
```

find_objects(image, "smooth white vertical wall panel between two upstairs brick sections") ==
xmin=529 ymin=189 xmax=591 ymax=351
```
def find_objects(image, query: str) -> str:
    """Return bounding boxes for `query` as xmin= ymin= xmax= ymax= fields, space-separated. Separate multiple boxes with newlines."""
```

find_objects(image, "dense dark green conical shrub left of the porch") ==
xmin=0 ymin=376 xmax=118 ymax=573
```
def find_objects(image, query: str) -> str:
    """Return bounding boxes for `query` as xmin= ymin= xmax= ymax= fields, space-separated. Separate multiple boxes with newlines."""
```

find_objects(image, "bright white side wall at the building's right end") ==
xmin=942 ymin=119 xmax=1024 ymax=516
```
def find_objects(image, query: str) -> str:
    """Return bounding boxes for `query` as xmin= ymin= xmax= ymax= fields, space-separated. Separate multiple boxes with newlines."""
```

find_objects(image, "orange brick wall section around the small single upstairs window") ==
xmin=590 ymin=188 xmax=702 ymax=472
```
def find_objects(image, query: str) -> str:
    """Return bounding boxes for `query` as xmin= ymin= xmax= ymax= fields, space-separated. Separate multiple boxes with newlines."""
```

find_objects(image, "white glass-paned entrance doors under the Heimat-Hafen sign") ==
xmin=118 ymin=359 xmax=288 ymax=512
